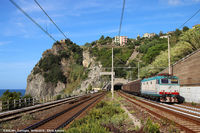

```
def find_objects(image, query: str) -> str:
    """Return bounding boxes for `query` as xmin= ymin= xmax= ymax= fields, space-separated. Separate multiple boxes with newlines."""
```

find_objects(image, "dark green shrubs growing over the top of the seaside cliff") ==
xmin=33 ymin=39 xmax=83 ymax=85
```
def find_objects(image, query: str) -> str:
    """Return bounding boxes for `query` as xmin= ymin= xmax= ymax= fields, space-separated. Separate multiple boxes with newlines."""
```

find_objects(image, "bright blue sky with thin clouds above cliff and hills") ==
xmin=0 ymin=0 xmax=200 ymax=89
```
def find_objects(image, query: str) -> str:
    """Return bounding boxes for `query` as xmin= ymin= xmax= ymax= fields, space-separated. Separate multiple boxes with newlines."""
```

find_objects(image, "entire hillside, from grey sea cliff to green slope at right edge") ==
xmin=26 ymin=26 xmax=200 ymax=97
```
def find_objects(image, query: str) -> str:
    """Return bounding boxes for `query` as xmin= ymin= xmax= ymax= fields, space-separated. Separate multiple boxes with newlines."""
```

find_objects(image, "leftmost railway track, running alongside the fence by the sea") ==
xmin=0 ymin=94 xmax=94 ymax=123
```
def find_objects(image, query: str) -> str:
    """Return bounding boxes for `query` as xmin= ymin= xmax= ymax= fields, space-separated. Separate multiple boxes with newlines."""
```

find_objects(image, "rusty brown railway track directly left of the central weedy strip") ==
xmin=17 ymin=92 xmax=105 ymax=133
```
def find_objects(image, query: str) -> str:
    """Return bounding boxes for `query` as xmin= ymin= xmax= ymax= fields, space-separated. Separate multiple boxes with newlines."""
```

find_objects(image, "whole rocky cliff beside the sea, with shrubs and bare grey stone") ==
xmin=26 ymin=39 xmax=105 ymax=98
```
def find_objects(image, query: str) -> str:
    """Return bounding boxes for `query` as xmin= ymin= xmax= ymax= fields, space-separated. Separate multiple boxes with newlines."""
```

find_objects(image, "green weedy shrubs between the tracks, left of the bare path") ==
xmin=66 ymin=101 xmax=127 ymax=133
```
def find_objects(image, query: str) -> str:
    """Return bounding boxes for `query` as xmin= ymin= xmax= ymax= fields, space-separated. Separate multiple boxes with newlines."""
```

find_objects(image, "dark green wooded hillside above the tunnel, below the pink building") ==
xmin=85 ymin=35 xmax=167 ymax=80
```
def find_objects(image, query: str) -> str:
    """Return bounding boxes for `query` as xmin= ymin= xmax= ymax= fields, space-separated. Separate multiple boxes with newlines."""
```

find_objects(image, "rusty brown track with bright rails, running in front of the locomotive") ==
xmin=118 ymin=92 xmax=200 ymax=133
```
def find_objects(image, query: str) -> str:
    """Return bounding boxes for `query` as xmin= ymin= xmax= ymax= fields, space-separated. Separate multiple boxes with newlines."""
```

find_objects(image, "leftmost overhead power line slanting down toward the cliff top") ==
xmin=10 ymin=0 xmax=56 ymax=42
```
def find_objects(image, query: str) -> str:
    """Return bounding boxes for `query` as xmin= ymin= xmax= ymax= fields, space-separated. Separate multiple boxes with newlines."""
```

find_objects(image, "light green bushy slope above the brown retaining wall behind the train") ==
xmin=140 ymin=26 xmax=200 ymax=77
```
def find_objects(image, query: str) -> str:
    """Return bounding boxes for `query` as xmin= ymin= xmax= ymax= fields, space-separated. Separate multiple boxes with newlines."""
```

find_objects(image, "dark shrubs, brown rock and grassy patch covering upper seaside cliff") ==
xmin=33 ymin=39 xmax=87 ymax=92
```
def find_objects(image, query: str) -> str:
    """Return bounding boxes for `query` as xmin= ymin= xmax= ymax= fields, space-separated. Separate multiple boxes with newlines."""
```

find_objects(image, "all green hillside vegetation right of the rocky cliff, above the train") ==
xmin=85 ymin=26 xmax=200 ymax=80
